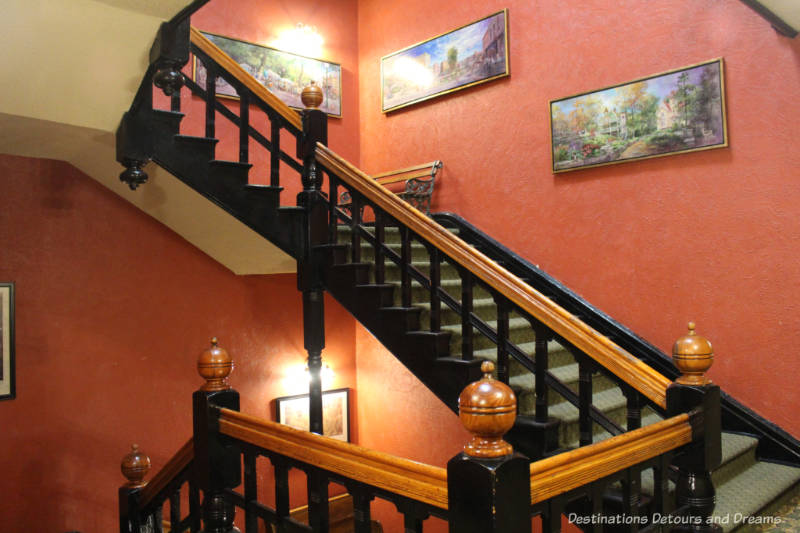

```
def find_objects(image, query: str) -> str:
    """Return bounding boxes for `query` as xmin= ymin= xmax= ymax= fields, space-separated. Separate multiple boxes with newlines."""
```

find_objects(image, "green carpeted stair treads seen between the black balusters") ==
xmin=330 ymin=222 xmax=800 ymax=532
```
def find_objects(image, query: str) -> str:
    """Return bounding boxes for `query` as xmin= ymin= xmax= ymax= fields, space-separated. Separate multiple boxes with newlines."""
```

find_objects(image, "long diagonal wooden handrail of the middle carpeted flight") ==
xmin=316 ymin=144 xmax=672 ymax=408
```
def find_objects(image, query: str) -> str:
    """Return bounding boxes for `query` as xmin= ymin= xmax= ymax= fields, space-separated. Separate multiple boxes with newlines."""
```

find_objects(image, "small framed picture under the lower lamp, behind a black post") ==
xmin=275 ymin=388 xmax=350 ymax=442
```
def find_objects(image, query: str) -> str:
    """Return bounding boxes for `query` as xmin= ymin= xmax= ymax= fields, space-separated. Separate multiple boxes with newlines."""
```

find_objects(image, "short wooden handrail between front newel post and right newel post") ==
xmin=531 ymin=413 xmax=692 ymax=505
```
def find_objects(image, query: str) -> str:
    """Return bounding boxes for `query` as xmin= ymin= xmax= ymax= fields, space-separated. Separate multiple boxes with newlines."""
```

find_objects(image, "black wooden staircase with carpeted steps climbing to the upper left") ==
xmin=117 ymin=14 xmax=800 ymax=531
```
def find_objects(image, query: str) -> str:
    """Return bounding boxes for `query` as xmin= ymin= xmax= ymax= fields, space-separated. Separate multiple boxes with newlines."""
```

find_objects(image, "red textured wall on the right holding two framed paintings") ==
xmin=358 ymin=0 xmax=800 ymax=435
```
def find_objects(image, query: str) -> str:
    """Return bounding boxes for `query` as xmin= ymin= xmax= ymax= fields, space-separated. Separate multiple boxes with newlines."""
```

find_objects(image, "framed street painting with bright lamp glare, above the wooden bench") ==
xmin=381 ymin=10 xmax=508 ymax=112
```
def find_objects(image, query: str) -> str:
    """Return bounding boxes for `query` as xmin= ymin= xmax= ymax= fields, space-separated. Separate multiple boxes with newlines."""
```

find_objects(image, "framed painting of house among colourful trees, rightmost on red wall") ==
xmin=550 ymin=59 xmax=728 ymax=172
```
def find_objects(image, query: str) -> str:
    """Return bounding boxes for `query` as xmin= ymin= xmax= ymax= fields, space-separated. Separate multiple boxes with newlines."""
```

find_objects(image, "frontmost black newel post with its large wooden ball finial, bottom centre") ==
xmin=447 ymin=361 xmax=531 ymax=533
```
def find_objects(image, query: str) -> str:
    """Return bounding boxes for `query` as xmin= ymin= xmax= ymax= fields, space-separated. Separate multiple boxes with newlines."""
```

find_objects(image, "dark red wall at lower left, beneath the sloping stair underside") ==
xmin=0 ymin=152 xmax=357 ymax=533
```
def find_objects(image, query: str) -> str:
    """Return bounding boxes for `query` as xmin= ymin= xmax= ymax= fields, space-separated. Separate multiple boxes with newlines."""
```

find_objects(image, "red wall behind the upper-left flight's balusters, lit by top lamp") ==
xmin=174 ymin=0 xmax=360 ymax=200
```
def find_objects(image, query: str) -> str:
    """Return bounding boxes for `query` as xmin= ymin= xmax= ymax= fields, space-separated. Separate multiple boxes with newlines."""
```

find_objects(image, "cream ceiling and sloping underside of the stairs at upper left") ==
xmin=0 ymin=0 xmax=296 ymax=274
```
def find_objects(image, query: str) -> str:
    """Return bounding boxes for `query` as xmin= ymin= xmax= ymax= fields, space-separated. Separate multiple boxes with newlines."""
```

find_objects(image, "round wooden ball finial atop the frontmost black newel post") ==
xmin=458 ymin=361 xmax=517 ymax=458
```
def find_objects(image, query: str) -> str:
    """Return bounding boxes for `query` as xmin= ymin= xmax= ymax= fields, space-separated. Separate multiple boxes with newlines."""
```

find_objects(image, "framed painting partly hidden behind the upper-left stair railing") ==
xmin=192 ymin=32 xmax=342 ymax=117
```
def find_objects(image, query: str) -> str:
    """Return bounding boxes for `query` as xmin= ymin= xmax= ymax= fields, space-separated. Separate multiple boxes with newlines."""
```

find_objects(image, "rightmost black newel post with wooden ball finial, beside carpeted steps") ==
xmin=667 ymin=322 xmax=722 ymax=533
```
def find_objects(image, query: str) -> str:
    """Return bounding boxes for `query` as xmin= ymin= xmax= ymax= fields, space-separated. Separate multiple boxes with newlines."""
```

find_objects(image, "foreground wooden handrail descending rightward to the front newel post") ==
xmin=219 ymin=409 xmax=447 ymax=509
